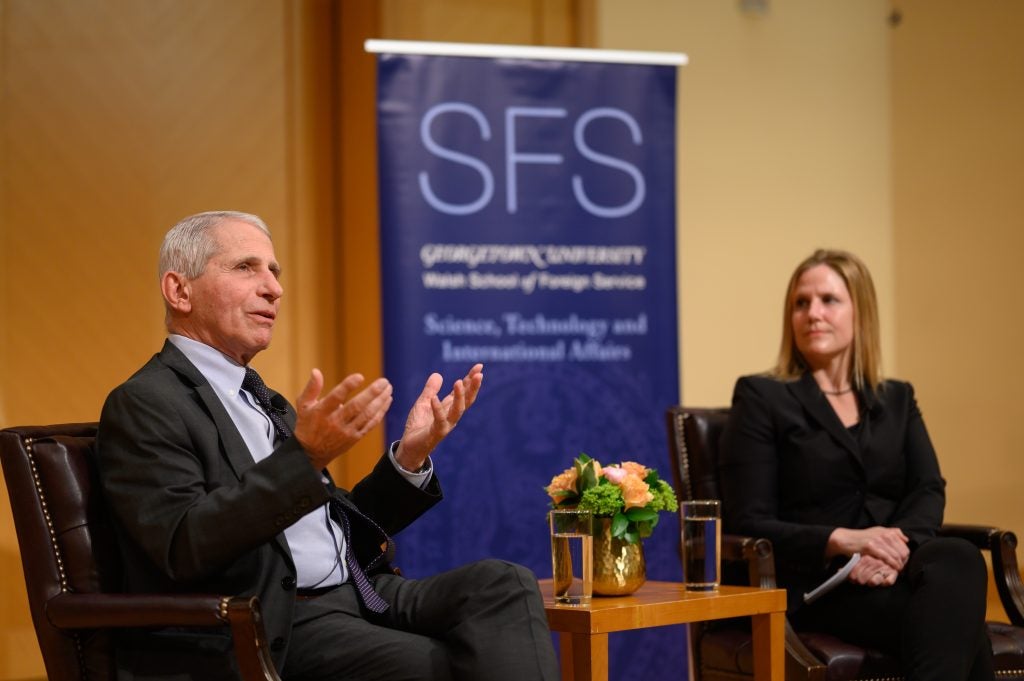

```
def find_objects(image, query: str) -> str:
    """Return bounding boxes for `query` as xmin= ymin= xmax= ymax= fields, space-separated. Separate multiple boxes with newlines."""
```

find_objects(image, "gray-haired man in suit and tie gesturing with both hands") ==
xmin=98 ymin=212 xmax=558 ymax=681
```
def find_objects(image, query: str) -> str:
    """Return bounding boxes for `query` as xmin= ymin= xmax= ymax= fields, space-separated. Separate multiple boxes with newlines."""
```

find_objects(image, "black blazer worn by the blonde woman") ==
xmin=719 ymin=374 xmax=945 ymax=609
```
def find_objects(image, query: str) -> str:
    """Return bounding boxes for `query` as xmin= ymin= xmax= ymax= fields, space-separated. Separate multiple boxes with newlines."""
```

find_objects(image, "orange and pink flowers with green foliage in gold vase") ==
xmin=544 ymin=454 xmax=678 ymax=544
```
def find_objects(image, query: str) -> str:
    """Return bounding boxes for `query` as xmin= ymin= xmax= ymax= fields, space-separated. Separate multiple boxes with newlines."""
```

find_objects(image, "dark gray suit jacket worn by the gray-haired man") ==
xmin=97 ymin=342 xmax=441 ymax=679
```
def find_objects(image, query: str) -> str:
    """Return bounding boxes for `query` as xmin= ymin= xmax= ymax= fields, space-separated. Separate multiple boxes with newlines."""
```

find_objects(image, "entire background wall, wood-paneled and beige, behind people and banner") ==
xmin=0 ymin=0 xmax=1024 ymax=680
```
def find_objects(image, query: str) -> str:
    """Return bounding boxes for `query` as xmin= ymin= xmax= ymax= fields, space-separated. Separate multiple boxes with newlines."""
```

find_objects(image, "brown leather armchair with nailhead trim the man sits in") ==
xmin=0 ymin=423 xmax=280 ymax=681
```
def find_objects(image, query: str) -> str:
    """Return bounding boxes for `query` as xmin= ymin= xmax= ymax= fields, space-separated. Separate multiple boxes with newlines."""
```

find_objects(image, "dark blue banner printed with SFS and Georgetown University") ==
xmin=378 ymin=47 xmax=686 ymax=681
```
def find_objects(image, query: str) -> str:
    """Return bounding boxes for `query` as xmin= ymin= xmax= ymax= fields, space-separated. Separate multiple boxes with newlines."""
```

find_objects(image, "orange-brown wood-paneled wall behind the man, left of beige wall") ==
xmin=0 ymin=0 xmax=586 ymax=680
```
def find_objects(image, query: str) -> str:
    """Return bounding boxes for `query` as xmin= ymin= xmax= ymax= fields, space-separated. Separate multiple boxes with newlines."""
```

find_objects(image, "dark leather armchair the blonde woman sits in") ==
xmin=667 ymin=407 xmax=1024 ymax=681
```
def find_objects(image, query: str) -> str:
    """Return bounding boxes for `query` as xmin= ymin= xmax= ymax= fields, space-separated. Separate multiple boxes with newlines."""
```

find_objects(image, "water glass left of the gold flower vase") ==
xmin=549 ymin=509 xmax=594 ymax=605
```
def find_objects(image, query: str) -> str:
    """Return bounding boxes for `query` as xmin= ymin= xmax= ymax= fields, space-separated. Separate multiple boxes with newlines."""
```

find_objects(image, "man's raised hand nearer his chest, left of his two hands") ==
xmin=295 ymin=369 xmax=391 ymax=470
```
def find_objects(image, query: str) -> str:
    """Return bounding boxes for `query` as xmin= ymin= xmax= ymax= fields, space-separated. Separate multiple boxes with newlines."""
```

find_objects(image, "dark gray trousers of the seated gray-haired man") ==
xmin=282 ymin=560 xmax=559 ymax=681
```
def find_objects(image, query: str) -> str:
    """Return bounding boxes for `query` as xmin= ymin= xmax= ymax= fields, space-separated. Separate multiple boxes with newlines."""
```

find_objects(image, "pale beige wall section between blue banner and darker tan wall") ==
xmin=596 ymin=0 xmax=895 ymax=406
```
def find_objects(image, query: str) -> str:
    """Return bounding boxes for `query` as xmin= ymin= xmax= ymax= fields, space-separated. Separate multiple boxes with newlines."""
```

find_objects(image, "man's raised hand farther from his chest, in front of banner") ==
xmin=394 ymin=365 xmax=483 ymax=471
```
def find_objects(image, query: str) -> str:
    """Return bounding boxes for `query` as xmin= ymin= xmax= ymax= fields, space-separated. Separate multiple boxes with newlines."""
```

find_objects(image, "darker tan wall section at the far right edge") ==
xmin=892 ymin=0 xmax=1024 ymax=533
